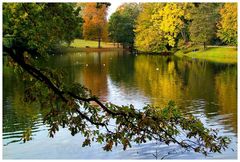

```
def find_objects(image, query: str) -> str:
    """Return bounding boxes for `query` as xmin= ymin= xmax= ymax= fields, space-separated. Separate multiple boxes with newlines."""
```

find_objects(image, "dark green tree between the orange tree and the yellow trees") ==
xmin=109 ymin=3 xmax=139 ymax=48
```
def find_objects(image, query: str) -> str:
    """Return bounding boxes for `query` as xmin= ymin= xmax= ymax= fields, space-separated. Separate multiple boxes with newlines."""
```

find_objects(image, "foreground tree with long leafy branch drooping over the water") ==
xmin=3 ymin=3 xmax=230 ymax=155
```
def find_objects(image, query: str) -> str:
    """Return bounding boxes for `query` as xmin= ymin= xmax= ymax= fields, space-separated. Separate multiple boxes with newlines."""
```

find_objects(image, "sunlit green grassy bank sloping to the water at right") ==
xmin=175 ymin=47 xmax=237 ymax=63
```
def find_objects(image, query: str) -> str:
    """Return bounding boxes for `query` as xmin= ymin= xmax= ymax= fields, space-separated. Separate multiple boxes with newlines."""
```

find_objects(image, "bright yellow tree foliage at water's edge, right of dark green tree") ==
xmin=135 ymin=3 xmax=193 ymax=52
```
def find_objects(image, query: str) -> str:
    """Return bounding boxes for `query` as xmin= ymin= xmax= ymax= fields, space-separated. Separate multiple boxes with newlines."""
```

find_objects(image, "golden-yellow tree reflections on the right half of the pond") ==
xmin=135 ymin=56 xmax=237 ymax=132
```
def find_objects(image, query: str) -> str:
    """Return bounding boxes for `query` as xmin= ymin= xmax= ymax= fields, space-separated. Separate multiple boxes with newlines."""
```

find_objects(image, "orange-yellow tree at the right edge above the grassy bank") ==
xmin=217 ymin=3 xmax=238 ymax=45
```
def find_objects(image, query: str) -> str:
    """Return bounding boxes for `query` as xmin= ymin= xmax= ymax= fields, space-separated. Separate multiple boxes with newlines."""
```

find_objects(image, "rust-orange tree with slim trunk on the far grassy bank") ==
xmin=83 ymin=3 xmax=109 ymax=48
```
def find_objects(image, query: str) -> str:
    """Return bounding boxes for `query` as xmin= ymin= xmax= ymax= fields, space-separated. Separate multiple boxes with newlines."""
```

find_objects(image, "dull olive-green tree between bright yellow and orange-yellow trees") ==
xmin=189 ymin=3 xmax=219 ymax=49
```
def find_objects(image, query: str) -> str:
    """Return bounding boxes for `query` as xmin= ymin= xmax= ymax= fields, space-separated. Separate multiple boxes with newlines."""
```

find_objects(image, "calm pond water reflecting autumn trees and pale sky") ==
xmin=3 ymin=52 xmax=237 ymax=159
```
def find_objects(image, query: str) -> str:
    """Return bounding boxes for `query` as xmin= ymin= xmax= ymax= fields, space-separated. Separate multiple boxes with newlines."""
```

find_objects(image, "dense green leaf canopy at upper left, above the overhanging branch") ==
xmin=3 ymin=3 xmax=82 ymax=54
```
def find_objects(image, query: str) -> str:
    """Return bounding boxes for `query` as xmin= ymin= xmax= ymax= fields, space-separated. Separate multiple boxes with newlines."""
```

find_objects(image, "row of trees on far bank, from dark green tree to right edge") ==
xmin=109 ymin=3 xmax=237 ymax=52
